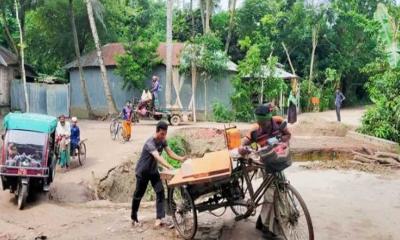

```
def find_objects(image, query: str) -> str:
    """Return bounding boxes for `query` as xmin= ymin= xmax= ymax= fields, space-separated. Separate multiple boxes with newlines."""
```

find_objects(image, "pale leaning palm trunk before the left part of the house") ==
xmin=85 ymin=0 xmax=117 ymax=114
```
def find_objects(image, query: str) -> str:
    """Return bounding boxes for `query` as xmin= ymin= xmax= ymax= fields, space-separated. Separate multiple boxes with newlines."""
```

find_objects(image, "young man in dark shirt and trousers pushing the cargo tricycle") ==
xmin=131 ymin=121 xmax=186 ymax=227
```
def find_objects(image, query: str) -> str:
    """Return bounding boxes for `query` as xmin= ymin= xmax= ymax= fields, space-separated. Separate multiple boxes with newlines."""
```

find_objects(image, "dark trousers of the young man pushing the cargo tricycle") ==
xmin=131 ymin=173 xmax=165 ymax=221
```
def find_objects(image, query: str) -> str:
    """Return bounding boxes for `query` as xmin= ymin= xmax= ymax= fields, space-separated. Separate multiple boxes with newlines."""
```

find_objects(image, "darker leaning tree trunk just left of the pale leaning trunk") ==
xmin=68 ymin=0 xmax=94 ymax=118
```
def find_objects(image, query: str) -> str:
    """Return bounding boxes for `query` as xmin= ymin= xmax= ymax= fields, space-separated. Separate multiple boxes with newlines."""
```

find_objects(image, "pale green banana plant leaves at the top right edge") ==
xmin=374 ymin=3 xmax=400 ymax=68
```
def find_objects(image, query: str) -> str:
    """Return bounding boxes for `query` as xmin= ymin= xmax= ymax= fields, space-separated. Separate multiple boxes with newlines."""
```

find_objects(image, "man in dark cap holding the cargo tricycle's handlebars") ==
xmin=239 ymin=104 xmax=291 ymax=239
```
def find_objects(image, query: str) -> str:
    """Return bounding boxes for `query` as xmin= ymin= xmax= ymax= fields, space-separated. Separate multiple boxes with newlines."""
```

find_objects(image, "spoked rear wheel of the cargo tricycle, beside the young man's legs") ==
xmin=168 ymin=187 xmax=197 ymax=240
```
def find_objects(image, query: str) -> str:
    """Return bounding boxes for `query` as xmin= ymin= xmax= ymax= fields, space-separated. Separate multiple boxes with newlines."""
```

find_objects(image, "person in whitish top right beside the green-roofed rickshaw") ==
xmin=56 ymin=115 xmax=71 ymax=168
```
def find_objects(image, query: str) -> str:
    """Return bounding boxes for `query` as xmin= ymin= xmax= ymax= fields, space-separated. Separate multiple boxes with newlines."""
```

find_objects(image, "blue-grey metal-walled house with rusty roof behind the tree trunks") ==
xmin=64 ymin=43 xmax=236 ymax=120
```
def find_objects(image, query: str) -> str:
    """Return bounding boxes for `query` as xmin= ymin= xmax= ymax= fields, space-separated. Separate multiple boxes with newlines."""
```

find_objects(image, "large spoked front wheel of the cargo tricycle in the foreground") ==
xmin=274 ymin=183 xmax=314 ymax=240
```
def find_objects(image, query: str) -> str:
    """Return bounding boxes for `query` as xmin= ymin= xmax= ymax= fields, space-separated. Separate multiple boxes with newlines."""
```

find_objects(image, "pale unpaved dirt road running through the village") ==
xmin=0 ymin=111 xmax=400 ymax=240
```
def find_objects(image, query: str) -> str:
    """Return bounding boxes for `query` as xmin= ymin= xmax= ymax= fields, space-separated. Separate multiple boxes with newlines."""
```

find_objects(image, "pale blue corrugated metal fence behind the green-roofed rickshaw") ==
xmin=11 ymin=80 xmax=70 ymax=116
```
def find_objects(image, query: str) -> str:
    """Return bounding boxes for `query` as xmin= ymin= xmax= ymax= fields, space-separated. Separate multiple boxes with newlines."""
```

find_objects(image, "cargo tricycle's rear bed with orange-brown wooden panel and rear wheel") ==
xmin=161 ymin=150 xmax=241 ymax=239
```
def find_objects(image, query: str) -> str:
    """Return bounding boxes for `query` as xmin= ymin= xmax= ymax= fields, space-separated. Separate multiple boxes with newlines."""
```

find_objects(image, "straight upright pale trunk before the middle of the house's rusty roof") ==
xmin=165 ymin=0 xmax=174 ymax=108
